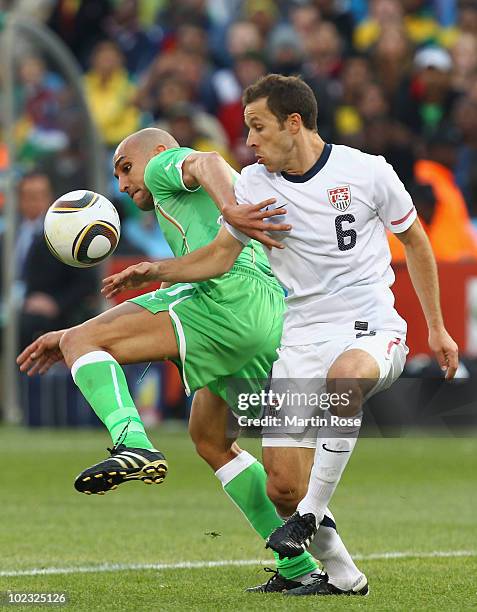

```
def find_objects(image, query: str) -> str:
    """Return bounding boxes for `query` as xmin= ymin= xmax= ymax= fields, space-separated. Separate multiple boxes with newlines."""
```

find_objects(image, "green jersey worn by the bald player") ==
xmin=144 ymin=147 xmax=272 ymax=277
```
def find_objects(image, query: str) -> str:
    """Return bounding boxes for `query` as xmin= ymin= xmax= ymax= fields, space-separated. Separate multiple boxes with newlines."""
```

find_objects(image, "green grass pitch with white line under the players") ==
xmin=0 ymin=428 xmax=477 ymax=612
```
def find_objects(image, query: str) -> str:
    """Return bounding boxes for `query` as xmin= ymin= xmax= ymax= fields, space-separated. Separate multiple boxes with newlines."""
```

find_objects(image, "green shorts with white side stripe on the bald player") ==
xmin=130 ymin=266 xmax=285 ymax=416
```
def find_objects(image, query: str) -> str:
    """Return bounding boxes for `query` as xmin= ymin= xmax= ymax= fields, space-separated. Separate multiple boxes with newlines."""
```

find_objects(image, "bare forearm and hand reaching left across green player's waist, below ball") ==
xmin=101 ymin=228 xmax=243 ymax=298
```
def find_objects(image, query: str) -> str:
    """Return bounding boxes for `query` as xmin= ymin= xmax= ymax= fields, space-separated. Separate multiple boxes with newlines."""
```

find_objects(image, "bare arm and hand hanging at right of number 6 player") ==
xmin=397 ymin=219 xmax=458 ymax=378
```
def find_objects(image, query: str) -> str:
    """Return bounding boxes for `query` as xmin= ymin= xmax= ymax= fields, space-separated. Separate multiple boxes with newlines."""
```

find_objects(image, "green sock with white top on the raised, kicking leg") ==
xmin=71 ymin=351 xmax=154 ymax=448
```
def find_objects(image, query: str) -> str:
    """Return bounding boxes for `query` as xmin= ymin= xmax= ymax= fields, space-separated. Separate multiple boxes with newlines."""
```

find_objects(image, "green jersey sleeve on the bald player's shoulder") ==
xmin=144 ymin=147 xmax=200 ymax=200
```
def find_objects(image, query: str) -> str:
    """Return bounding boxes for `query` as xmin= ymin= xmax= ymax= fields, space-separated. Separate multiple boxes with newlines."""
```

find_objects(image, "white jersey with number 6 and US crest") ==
xmin=225 ymin=144 xmax=416 ymax=346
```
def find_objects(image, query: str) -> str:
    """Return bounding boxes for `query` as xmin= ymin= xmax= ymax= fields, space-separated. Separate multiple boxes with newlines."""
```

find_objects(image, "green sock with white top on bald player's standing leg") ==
xmin=215 ymin=451 xmax=318 ymax=580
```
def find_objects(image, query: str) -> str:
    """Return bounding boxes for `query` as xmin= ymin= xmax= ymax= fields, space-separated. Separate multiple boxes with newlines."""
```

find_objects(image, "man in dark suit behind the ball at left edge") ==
xmin=15 ymin=171 xmax=98 ymax=348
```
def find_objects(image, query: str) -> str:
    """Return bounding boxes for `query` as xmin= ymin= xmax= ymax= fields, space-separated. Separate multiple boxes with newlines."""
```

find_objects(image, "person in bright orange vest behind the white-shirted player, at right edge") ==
xmin=390 ymin=130 xmax=477 ymax=261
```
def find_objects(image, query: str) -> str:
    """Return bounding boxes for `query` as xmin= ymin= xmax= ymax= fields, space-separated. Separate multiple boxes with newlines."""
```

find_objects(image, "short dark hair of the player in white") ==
xmin=242 ymin=74 xmax=318 ymax=130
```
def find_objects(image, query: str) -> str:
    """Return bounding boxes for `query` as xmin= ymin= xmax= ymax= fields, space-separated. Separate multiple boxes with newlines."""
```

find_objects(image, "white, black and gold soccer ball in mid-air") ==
xmin=44 ymin=190 xmax=121 ymax=268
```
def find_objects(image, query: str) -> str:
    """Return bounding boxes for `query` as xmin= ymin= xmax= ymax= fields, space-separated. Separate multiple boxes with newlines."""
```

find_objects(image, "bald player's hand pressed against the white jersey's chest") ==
xmin=222 ymin=198 xmax=291 ymax=249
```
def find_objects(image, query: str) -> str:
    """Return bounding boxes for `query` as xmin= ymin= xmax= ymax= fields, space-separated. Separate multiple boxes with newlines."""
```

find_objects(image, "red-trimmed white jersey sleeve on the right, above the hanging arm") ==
xmin=374 ymin=156 xmax=417 ymax=234
